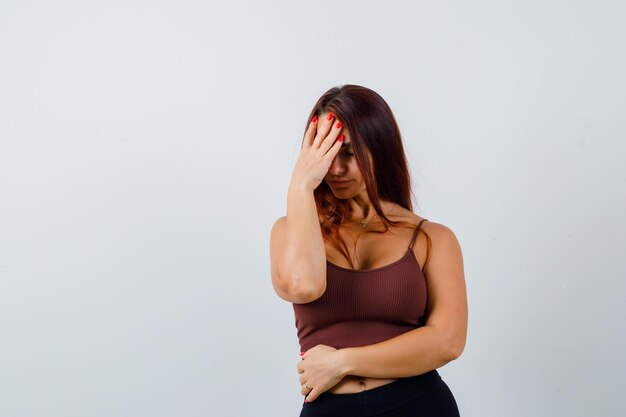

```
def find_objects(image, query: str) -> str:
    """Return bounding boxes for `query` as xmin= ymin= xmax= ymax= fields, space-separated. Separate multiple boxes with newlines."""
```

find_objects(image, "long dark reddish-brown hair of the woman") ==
xmin=306 ymin=84 xmax=430 ymax=267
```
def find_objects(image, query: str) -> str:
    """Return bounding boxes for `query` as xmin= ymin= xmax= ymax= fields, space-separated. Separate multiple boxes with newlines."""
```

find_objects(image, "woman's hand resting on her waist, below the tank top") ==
xmin=298 ymin=345 xmax=346 ymax=402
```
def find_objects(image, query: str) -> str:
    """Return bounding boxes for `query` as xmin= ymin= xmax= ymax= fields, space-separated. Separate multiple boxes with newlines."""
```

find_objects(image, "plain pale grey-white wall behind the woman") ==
xmin=0 ymin=0 xmax=626 ymax=417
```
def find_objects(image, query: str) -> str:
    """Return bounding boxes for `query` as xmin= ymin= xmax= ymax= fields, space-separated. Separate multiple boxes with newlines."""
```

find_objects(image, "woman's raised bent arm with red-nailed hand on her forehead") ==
xmin=270 ymin=115 xmax=343 ymax=303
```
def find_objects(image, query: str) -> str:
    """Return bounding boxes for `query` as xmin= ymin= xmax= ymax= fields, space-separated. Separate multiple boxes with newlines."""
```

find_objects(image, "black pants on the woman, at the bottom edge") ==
xmin=300 ymin=371 xmax=459 ymax=417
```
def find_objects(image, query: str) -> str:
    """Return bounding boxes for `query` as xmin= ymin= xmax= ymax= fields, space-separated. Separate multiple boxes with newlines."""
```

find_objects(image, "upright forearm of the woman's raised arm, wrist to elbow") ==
xmin=278 ymin=183 xmax=326 ymax=301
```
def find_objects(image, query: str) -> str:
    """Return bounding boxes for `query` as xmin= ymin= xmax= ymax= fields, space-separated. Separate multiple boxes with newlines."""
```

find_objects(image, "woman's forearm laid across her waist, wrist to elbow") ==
xmin=340 ymin=326 xmax=463 ymax=378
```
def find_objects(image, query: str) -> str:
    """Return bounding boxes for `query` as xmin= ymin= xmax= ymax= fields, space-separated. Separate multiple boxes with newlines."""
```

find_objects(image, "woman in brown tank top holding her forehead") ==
xmin=270 ymin=85 xmax=467 ymax=417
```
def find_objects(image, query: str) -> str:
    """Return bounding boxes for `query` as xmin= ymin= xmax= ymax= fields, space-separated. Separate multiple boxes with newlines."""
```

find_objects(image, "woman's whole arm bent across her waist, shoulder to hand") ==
xmin=298 ymin=222 xmax=467 ymax=401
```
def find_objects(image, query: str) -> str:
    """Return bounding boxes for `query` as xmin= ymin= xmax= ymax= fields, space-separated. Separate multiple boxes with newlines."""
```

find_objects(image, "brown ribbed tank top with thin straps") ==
xmin=293 ymin=219 xmax=427 ymax=352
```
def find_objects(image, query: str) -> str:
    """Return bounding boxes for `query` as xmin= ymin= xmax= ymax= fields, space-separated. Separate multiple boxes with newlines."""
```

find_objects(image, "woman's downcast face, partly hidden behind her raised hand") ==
xmin=324 ymin=129 xmax=367 ymax=199
